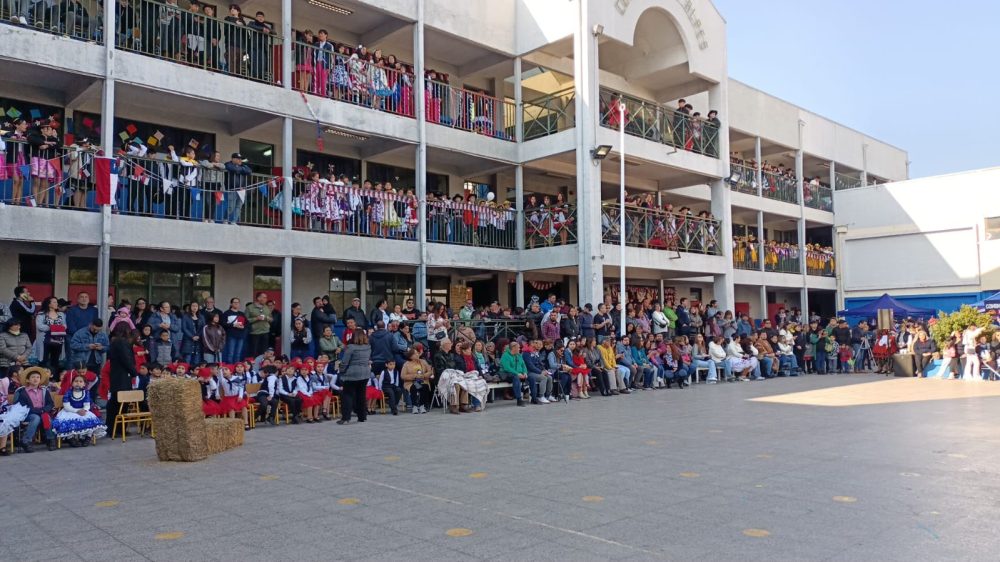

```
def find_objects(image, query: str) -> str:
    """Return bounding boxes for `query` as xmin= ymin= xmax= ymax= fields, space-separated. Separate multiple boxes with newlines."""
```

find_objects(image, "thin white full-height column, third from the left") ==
xmin=413 ymin=0 xmax=427 ymax=310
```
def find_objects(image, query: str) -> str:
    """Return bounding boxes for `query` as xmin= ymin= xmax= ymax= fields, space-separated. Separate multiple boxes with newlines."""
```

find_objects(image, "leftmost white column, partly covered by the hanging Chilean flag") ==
xmin=97 ymin=3 xmax=118 ymax=324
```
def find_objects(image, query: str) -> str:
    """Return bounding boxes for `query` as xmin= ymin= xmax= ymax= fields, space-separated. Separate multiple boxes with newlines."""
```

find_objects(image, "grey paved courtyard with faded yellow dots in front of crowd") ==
xmin=0 ymin=375 xmax=1000 ymax=562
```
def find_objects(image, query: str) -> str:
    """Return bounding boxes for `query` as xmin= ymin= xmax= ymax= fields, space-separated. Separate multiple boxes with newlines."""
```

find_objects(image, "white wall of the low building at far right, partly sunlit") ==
xmin=834 ymin=168 xmax=1000 ymax=297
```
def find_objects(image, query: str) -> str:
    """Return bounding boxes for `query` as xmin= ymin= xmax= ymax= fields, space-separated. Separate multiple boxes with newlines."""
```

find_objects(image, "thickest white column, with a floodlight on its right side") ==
xmin=572 ymin=0 xmax=604 ymax=307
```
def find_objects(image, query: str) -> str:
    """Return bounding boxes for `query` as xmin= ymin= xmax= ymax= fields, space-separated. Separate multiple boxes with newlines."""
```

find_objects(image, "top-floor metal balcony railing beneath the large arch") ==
xmin=600 ymin=88 xmax=719 ymax=158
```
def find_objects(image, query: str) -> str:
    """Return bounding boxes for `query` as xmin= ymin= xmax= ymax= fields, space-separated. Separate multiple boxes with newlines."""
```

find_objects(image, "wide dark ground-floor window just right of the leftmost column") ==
xmin=112 ymin=261 xmax=215 ymax=306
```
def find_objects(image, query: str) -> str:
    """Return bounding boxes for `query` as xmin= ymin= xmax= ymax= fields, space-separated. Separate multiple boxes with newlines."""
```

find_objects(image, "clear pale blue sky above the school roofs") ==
xmin=714 ymin=0 xmax=1000 ymax=178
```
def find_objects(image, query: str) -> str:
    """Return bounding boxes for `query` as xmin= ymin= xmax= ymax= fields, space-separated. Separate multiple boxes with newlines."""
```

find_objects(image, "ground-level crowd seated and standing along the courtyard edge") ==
xmin=7 ymin=280 xmax=1000 ymax=451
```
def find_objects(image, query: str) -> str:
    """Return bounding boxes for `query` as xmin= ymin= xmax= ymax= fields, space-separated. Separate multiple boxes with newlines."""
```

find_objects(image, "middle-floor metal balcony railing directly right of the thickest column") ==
xmin=601 ymin=203 xmax=722 ymax=256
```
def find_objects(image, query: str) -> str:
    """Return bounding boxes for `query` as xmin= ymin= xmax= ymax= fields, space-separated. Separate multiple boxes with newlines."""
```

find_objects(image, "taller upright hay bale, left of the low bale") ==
xmin=147 ymin=378 xmax=207 ymax=462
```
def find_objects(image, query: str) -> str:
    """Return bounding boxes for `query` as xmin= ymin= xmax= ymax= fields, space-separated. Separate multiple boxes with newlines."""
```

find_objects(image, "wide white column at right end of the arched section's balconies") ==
xmin=708 ymin=82 xmax=736 ymax=310
